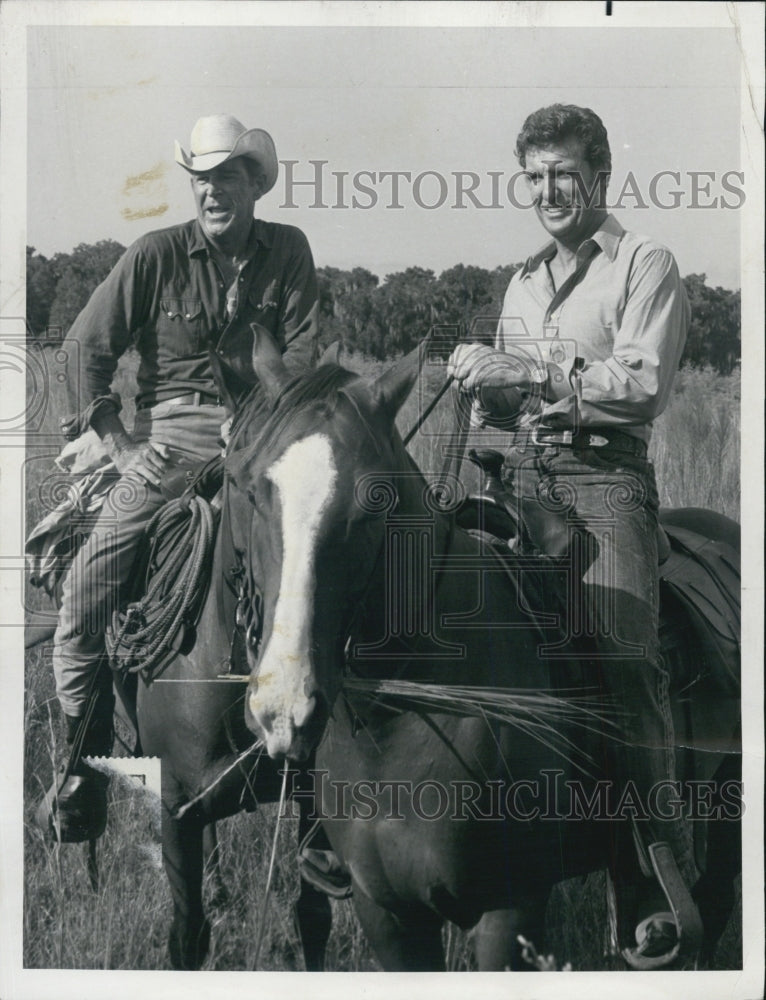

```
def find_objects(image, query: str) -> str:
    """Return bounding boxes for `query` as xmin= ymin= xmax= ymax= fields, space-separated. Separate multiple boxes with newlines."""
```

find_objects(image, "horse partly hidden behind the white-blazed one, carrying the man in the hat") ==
xmin=106 ymin=376 xmax=338 ymax=971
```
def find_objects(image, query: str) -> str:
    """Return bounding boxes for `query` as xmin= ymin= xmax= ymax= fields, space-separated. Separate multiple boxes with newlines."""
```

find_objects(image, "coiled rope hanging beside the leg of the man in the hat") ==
xmin=106 ymin=493 xmax=216 ymax=676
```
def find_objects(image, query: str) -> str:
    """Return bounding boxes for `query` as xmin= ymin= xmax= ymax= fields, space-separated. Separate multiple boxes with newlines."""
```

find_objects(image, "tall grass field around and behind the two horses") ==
xmin=24 ymin=344 xmax=740 ymax=971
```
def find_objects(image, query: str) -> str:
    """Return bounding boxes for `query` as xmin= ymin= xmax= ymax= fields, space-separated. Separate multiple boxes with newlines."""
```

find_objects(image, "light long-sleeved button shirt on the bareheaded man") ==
xmin=488 ymin=215 xmax=690 ymax=441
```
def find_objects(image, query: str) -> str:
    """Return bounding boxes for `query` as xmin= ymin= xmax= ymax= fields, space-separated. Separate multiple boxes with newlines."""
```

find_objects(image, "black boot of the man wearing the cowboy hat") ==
xmin=35 ymin=715 xmax=113 ymax=844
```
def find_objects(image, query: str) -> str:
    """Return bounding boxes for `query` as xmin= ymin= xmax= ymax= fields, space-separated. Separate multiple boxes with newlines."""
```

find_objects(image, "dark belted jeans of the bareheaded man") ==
xmin=503 ymin=446 xmax=689 ymax=865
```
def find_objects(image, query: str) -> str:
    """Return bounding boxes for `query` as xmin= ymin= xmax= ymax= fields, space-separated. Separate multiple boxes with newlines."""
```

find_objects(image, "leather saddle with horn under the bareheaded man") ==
xmin=456 ymin=449 xmax=741 ymax=696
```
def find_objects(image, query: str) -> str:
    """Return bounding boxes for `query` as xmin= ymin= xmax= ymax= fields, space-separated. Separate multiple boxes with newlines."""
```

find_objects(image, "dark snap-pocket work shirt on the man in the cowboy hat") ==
xmin=65 ymin=220 xmax=317 ymax=409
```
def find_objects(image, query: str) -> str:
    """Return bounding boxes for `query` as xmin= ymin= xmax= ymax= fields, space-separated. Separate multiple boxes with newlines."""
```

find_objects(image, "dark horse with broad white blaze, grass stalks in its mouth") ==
xmin=227 ymin=338 xmax=739 ymax=971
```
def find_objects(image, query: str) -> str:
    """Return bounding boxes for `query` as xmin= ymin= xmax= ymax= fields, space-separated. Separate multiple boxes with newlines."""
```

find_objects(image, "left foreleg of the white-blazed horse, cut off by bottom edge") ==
xmin=354 ymin=884 xmax=444 ymax=972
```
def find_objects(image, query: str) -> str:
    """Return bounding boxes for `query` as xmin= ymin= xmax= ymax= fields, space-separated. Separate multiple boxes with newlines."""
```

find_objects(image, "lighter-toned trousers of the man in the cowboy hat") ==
xmin=53 ymin=403 xmax=226 ymax=716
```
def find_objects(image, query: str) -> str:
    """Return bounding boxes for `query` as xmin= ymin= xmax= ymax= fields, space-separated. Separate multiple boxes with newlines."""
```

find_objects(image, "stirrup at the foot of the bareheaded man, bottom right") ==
xmin=622 ymin=841 xmax=703 ymax=971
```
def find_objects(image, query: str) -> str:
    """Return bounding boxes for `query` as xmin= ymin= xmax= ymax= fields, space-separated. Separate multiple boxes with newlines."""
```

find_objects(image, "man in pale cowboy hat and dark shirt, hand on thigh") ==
xmin=38 ymin=114 xmax=317 ymax=840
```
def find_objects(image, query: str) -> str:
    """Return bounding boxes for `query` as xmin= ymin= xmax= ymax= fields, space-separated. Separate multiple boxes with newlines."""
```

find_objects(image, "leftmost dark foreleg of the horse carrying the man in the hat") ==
xmin=162 ymin=808 xmax=210 ymax=970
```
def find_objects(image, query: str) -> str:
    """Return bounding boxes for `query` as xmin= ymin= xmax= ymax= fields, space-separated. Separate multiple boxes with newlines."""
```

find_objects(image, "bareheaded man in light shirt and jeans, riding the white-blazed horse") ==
xmin=449 ymin=104 xmax=700 ymax=967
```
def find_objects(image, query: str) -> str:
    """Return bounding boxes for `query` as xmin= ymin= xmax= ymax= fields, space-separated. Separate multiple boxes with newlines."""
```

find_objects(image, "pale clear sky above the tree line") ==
xmin=27 ymin=26 xmax=748 ymax=288
